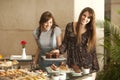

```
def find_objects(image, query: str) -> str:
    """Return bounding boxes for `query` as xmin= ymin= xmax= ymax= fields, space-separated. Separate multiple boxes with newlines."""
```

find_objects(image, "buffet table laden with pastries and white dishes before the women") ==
xmin=0 ymin=55 xmax=93 ymax=80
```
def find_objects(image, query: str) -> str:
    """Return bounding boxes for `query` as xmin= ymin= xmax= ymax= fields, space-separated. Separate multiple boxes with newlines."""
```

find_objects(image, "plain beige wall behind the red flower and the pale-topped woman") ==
xmin=0 ymin=0 xmax=74 ymax=57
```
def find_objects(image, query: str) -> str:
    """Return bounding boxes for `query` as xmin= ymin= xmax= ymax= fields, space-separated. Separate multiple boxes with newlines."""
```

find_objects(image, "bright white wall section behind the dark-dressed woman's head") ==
xmin=74 ymin=0 xmax=104 ymax=21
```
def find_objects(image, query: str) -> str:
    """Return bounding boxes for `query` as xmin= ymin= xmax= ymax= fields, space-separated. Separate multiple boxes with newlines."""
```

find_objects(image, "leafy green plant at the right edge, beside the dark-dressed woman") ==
xmin=96 ymin=21 xmax=120 ymax=80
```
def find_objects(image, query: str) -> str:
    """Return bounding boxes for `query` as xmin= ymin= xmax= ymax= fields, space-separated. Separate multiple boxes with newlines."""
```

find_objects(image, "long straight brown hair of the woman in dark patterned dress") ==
xmin=76 ymin=7 xmax=96 ymax=52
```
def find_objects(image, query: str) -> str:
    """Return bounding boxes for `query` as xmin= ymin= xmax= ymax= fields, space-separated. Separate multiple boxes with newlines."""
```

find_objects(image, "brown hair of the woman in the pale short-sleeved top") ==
xmin=38 ymin=11 xmax=57 ymax=38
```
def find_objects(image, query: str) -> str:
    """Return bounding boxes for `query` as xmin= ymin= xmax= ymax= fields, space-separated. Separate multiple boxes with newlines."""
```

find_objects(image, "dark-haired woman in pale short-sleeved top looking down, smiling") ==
xmin=33 ymin=11 xmax=62 ymax=70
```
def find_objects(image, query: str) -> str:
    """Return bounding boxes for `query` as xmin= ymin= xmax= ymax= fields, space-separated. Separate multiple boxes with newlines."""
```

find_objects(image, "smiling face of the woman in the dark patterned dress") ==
xmin=81 ymin=11 xmax=90 ymax=25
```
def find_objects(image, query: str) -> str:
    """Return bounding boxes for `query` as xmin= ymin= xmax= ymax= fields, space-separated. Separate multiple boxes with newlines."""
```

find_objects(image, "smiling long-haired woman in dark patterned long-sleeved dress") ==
xmin=59 ymin=7 xmax=99 ymax=71
